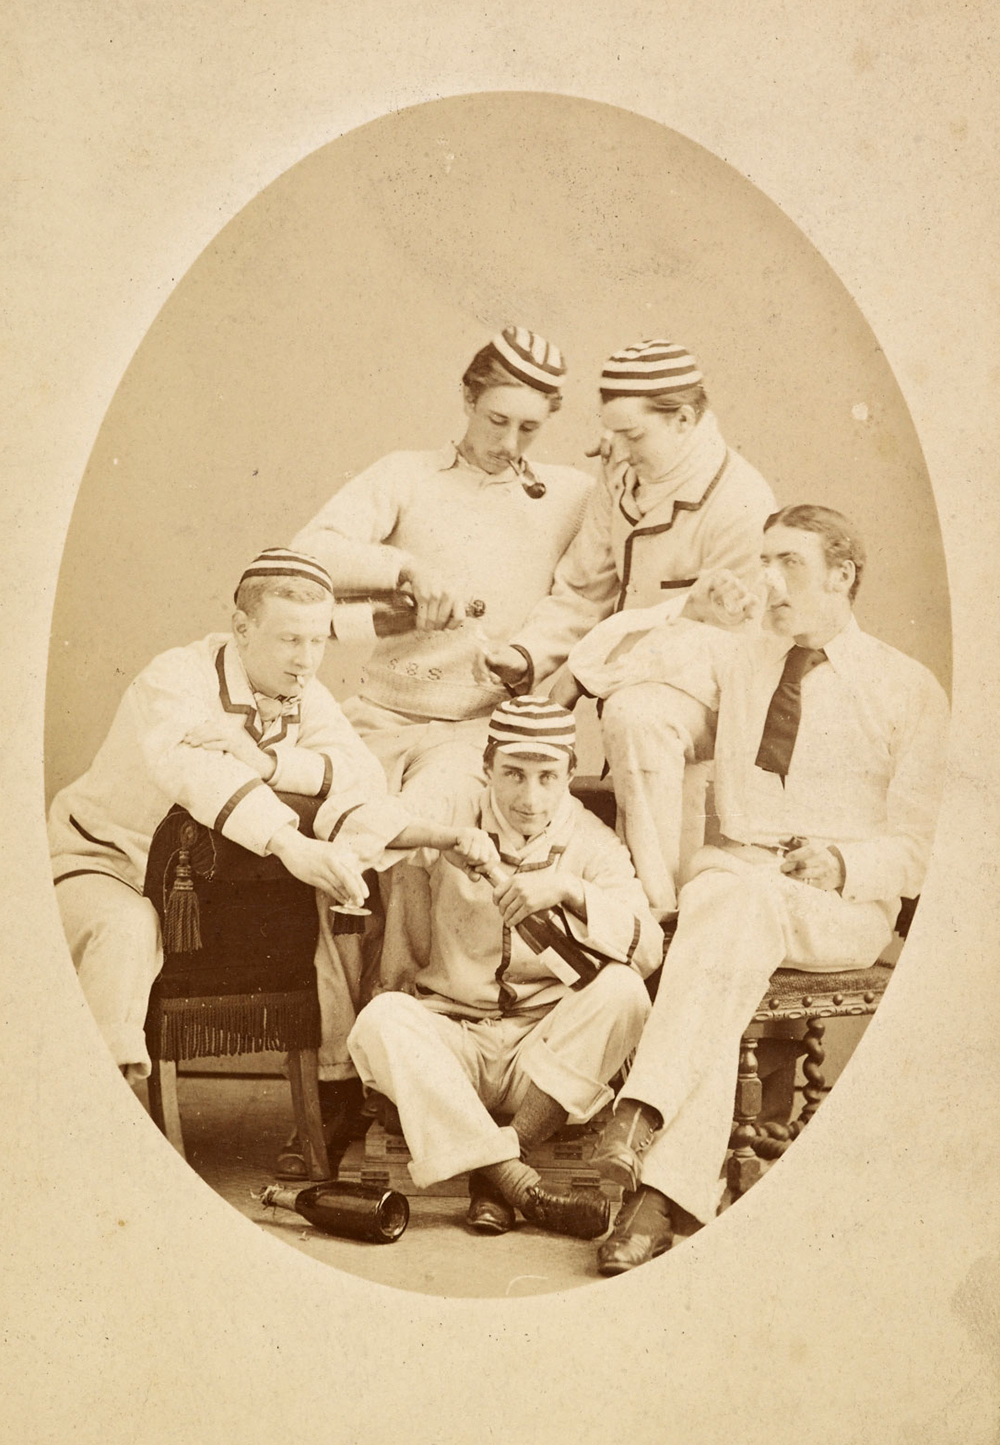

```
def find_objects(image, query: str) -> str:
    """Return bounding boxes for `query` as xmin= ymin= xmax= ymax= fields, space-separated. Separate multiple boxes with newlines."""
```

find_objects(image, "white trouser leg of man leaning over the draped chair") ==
xmin=55 ymin=873 xmax=163 ymax=1078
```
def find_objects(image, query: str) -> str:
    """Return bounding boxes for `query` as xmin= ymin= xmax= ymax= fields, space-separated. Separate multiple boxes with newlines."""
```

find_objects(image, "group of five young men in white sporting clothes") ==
xmin=51 ymin=328 xmax=947 ymax=1274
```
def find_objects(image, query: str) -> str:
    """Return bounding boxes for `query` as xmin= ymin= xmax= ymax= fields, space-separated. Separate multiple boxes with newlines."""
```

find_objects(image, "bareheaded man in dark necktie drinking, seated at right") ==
xmin=571 ymin=506 xmax=948 ymax=1274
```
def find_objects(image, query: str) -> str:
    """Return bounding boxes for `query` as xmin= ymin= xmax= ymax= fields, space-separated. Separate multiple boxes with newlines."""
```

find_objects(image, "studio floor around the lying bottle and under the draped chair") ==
xmin=142 ymin=1075 xmax=719 ymax=1298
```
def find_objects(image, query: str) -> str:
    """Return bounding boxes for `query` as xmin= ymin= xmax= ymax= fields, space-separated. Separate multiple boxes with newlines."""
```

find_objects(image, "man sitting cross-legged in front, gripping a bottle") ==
xmin=348 ymin=695 xmax=663 ymax=1238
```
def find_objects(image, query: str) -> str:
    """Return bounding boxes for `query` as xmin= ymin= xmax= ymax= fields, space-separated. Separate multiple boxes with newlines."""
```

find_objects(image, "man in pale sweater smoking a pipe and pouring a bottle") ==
xmin=292 ymin=327 xmax=594 ymax=796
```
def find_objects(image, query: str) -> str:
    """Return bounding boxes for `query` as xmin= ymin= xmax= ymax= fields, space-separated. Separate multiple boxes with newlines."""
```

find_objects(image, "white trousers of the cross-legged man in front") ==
xmin=348 ymin=964 xmax=649 ymax=1188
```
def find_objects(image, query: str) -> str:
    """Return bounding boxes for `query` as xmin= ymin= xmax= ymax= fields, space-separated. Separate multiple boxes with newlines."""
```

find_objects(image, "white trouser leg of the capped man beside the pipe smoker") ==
xmin=601 ymin=682 xmax=714 ymax=918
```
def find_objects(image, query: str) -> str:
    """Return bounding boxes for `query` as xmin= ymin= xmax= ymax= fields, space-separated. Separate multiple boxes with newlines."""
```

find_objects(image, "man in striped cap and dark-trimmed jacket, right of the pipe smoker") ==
xmin=483 ymin=341 xmax=775 ymax=915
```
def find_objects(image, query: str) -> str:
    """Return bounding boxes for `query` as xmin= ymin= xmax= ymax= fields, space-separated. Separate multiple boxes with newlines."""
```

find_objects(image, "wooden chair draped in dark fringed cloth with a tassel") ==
xmin=145 ymin=795 xmax=329 ymax=1179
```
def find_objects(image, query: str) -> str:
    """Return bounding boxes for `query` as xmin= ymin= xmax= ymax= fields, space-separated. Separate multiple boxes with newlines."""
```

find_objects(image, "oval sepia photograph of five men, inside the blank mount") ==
xmin=46 ymin=94 xmax=951 ymax=1296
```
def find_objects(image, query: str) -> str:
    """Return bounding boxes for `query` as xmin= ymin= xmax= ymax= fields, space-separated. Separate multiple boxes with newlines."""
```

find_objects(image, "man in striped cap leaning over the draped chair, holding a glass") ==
xmin=49 ymin=548 xmax=493 ymax=1103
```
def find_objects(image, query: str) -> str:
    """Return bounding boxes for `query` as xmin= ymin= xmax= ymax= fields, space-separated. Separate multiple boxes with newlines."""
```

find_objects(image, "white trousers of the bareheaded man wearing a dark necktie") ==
xmin=623 ymin=844 xmax=892 ymax=1222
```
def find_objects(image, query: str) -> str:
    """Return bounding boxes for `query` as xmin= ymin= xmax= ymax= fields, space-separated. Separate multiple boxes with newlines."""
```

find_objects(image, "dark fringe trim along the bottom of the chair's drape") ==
xmin=146 ymin=993 xmax=319 ymax=1059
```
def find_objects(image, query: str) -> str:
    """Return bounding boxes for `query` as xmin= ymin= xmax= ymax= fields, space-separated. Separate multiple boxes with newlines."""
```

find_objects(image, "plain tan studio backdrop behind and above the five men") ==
xmin=46 ymin=92 xmax=951 ymax=796
